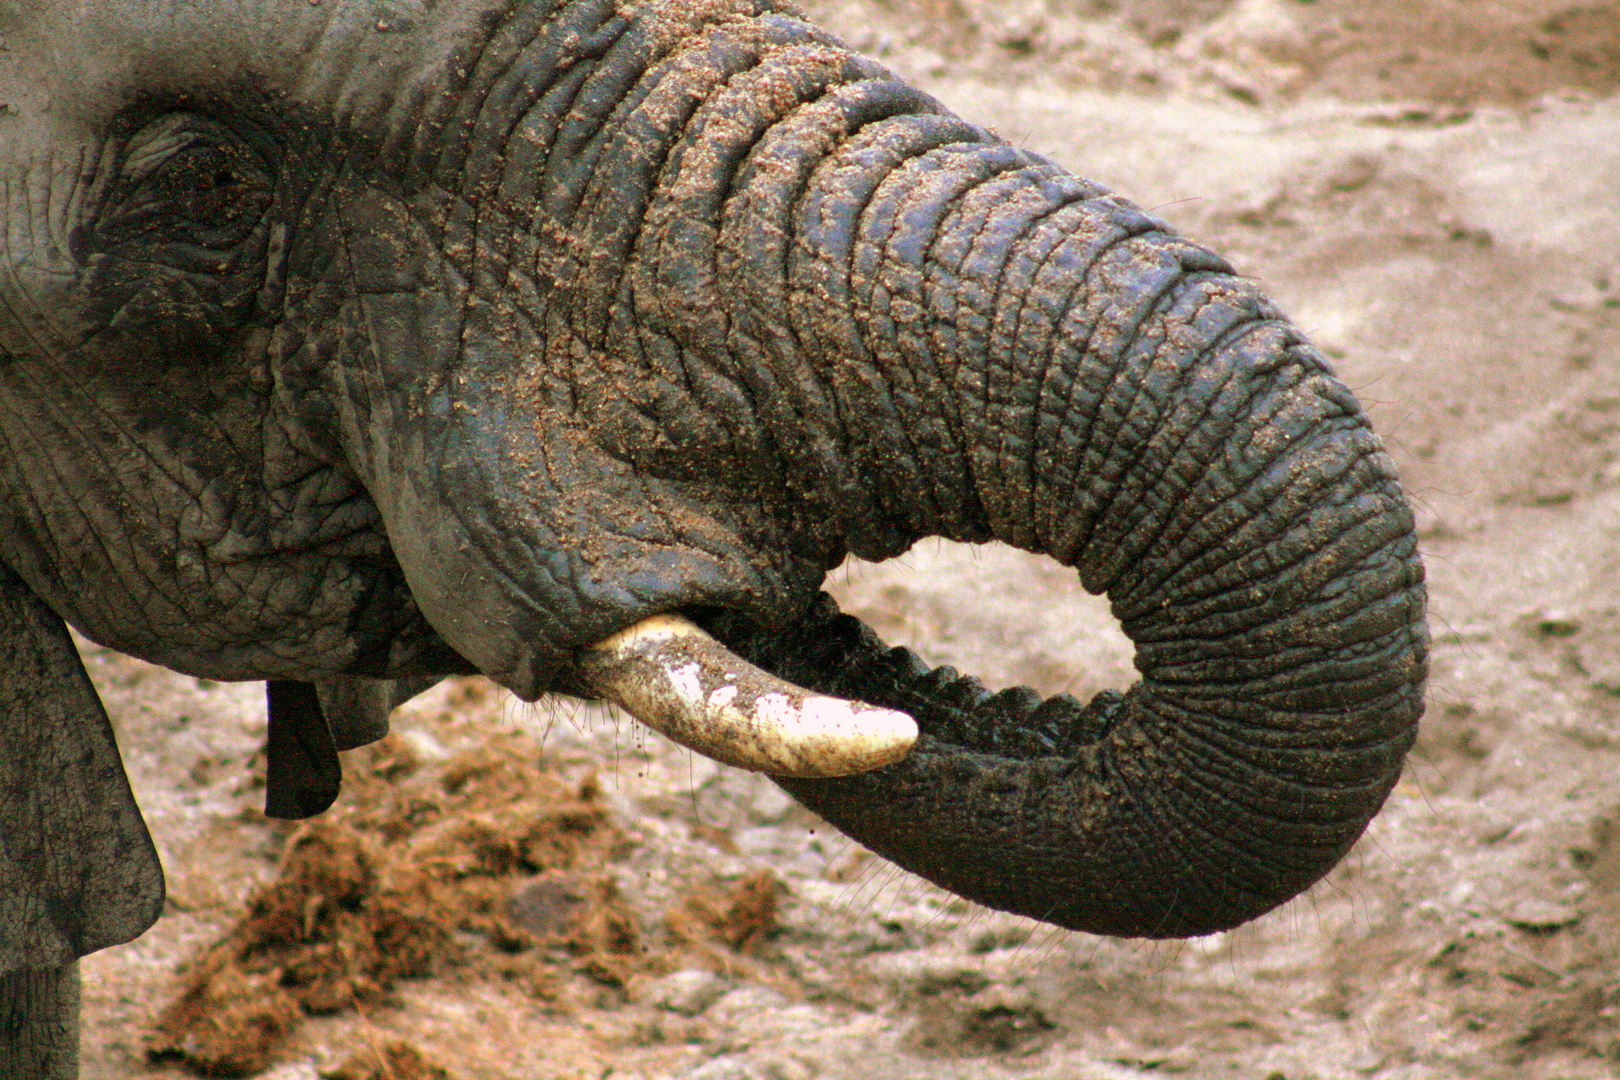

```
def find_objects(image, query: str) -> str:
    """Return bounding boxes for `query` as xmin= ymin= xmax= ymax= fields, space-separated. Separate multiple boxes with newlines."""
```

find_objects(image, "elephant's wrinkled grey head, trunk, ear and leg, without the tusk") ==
xmin=0 ymin=0 xmax=1426 ymax=1077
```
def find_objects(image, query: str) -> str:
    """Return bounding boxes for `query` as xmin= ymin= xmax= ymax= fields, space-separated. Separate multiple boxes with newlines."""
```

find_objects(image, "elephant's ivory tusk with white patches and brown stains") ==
xmin=578 ymin=615 xmax=917 ymax=777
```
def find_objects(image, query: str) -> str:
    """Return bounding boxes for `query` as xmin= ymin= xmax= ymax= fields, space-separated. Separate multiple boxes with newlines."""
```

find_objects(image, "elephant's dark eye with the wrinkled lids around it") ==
xmin=73 ymin=113 xmax=275 ymax=359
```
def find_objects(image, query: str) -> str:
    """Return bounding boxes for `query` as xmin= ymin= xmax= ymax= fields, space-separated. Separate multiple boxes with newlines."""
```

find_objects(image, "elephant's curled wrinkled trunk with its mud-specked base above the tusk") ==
xmin=343 ymin=0 xmax=1426 ymax=936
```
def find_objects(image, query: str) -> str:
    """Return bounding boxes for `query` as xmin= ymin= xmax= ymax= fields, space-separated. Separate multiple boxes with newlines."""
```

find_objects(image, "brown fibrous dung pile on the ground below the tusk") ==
xmin=152 ymin=733 xmax=638 ymax=1075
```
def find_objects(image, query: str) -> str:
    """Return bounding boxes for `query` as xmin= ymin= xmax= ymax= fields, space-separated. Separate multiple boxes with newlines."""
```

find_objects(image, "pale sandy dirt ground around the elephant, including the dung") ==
xmin=84 ymin=0 xmax=1620 ymax=1080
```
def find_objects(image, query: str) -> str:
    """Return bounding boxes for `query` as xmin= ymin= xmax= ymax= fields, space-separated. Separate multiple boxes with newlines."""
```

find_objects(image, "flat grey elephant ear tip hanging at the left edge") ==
xmin=0 ymin=565 xmax=164 ymax=973
